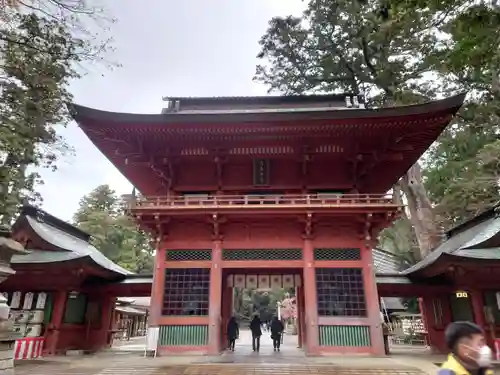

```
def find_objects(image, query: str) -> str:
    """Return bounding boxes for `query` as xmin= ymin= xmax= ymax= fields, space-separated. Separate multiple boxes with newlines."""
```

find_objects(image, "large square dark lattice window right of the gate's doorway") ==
xmin=316 ymin=268 xmax=366 ymax=316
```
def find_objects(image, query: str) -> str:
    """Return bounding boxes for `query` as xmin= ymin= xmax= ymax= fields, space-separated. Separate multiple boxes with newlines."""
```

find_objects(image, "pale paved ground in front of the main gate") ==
xmin=15 ymin=331 xmax=437 ymax=375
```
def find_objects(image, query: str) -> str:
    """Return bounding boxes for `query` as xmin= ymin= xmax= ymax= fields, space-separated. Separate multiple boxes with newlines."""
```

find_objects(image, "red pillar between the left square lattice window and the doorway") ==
xmin=208 ymin=240 xmax=222 ymax=355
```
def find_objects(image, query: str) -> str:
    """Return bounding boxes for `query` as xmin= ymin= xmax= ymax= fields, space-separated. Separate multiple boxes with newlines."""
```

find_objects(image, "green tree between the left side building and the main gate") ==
xmin=73 ymin=185 xmax=154 ymax=274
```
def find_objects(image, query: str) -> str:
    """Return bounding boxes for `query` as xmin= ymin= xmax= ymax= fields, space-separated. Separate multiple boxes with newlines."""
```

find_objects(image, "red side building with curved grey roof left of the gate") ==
xmin=0 ymin=206 xmax=151 ymax=359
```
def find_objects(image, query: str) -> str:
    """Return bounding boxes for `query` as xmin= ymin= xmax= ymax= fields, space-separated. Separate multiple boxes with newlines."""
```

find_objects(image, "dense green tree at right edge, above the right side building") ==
xmin=420 ymin=0 xmax=500 ymax=227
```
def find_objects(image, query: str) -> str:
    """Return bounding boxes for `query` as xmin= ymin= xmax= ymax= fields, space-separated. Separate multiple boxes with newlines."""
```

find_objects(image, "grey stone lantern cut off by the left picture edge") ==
xmin=0 ymin=227 xmax=28 ymax=375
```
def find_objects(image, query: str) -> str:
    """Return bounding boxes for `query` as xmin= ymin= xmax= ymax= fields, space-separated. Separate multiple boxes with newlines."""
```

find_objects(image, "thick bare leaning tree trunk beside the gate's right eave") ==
xmin=399 ymin=162 xmax=442 ymax=258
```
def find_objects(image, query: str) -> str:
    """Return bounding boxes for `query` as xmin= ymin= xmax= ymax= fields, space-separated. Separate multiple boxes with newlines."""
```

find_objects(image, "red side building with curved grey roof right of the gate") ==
xmin=377 ymin=205 xmax=500 ymax=355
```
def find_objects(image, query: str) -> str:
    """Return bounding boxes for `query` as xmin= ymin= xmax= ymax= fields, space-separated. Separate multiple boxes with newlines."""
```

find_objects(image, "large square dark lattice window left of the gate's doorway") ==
xmin=163 ymin=268 xmax=210 ymax=316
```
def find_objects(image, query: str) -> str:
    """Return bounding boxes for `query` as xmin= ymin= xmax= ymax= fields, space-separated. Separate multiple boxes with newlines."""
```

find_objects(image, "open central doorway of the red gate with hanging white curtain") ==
xmin=221 ymin=268 xmax=306 ymax=356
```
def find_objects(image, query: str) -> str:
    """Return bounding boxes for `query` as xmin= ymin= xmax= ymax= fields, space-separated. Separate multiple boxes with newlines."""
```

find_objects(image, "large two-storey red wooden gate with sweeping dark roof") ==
xmin=72 ymin=95 xmax=464 ymax=355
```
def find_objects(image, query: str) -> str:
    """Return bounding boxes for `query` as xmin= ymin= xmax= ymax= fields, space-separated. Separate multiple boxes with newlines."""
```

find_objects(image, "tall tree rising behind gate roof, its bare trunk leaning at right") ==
xmin=256 ymin=0 xmax=440 ymax=255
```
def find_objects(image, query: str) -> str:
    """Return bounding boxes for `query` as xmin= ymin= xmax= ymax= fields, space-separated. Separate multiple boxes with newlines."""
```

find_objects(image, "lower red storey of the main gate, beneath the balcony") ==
xmin=150 ymin=214 xmax=398 ymax=354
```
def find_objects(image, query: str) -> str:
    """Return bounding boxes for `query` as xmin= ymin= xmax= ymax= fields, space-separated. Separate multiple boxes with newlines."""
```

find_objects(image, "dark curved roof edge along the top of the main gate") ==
xmin=68 ymin=93 xmax=466 ymax=125
